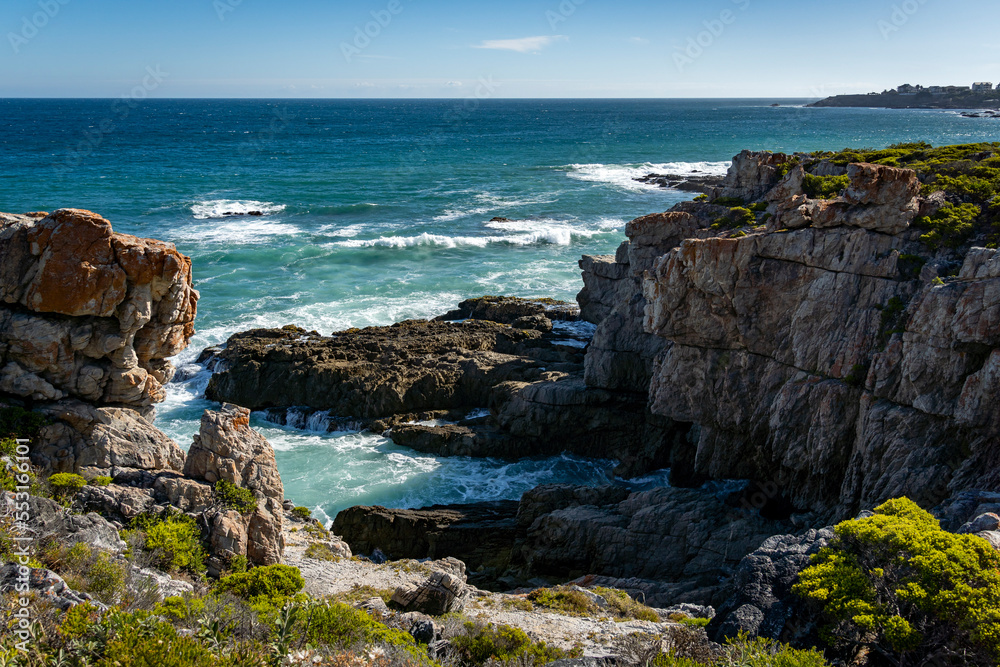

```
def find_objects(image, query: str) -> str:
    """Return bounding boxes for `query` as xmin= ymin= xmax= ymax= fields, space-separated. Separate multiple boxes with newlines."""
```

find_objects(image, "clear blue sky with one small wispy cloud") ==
xmin=0 ymin=0 xmax=1000 ymax=98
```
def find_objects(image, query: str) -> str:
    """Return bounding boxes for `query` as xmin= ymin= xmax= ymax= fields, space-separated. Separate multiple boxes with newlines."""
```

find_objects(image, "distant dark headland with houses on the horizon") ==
xmin=809 ymin=81 xmax=1000 ymax=109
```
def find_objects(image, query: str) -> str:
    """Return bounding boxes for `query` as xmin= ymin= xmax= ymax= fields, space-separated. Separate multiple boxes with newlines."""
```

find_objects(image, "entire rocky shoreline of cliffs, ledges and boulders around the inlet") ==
xmin=0 ymin=142 xmax=1000 ymax=655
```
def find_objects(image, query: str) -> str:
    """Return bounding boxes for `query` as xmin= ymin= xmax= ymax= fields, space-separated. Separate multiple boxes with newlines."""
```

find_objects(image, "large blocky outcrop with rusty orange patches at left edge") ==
xmin=0 ymin=209 xmax=198 ymax=408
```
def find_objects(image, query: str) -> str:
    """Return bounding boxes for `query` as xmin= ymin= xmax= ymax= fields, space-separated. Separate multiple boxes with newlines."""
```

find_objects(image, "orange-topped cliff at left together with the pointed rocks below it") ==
xmin=0 ymin=209 xmax=284 ymax=570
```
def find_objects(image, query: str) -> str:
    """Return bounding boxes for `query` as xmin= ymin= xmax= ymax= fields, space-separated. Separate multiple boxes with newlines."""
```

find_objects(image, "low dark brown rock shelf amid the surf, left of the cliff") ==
xmin=207 ymin=320 xmax=560 ymax=419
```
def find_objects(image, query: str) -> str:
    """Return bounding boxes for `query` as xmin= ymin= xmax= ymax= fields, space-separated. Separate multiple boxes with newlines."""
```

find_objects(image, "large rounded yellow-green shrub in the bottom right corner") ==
xmin=793 ymin=498 xmax=1000 ymax=665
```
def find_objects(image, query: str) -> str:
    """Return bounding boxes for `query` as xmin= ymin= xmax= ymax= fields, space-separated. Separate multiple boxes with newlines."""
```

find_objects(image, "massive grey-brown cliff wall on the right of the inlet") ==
xmin=580 ymin=153 xmax=1000 ymax=519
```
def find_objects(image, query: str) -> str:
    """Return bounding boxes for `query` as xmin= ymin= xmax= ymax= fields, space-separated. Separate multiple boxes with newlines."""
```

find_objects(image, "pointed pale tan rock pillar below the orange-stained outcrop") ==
xmin=184 ymin=405 xmax=285 ymax=565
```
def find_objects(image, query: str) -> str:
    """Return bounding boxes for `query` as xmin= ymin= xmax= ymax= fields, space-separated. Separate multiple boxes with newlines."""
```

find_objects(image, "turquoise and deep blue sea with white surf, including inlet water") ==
xmin=0 ymin=100 xmax=1000 ymax=517
